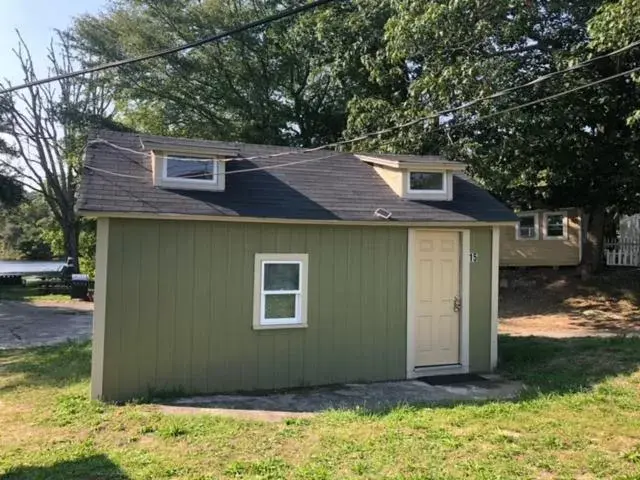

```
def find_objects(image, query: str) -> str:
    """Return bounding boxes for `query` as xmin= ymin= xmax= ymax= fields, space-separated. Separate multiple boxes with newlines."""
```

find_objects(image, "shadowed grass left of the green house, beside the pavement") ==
xmin=0 ymin=342 xmax=91 ymax=392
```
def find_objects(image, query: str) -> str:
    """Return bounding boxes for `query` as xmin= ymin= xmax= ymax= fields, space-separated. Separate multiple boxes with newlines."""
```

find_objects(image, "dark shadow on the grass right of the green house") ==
xmin=498 ymin=335 xmax=640 ymax=394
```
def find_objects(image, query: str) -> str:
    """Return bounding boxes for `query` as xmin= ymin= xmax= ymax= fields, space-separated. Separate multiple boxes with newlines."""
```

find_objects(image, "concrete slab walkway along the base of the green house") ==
xmin=160 ymin=375 xmax=523 ymax=421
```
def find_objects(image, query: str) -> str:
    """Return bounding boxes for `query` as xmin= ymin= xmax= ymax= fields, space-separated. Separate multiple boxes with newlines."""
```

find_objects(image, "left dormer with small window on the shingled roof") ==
xmin=145 ymin=143 xmax=238 ymax=192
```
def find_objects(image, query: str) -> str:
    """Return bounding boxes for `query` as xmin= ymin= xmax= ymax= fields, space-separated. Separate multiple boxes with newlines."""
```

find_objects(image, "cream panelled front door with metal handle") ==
xmin=413 ymin=230 xmax=461 ymax=367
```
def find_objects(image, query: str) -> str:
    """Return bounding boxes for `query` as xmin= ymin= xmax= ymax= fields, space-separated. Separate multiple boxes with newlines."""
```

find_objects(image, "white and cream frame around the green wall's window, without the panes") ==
xmin=253 ymin=253 xmax=309 ymax=330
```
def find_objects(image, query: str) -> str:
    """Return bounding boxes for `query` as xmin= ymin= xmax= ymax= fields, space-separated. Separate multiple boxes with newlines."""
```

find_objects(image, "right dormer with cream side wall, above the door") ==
xmin=357 ymin=154 xmax=465 ymax=200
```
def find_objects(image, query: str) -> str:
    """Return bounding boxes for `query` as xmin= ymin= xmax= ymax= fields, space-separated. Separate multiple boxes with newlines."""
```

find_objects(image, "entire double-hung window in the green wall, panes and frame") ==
xmin=253 ymin=253 xmax=308 ymax=329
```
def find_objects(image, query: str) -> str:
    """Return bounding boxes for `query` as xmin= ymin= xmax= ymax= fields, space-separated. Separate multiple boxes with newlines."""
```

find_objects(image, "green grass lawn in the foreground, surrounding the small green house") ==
xmin=0 ymin=338 xmax=640 ymax=479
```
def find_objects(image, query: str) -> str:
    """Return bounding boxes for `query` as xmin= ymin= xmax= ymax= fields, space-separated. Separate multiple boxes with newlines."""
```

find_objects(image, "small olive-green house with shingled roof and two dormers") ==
xmin=79 ymin=131 xmax=517 ymax=400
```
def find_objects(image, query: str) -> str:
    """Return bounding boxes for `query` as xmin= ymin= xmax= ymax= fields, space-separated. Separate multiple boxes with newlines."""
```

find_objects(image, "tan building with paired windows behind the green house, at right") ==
xmin=500 ymin=208 xmax=582 ymax=267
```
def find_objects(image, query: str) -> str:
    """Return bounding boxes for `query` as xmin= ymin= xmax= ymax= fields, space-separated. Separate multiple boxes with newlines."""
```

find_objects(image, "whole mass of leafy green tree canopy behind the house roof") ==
xmin=45 ymin=0 xmax=640 ymax=268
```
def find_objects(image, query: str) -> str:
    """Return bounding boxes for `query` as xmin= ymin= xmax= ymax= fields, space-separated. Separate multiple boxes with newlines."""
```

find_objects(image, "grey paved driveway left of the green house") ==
xmin=0 ymin=301 xmax=93 ymax=349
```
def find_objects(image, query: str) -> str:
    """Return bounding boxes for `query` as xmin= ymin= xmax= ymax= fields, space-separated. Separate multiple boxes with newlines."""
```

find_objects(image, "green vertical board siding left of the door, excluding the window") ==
xmin=100 ymin=219 xmax=407 ymax=400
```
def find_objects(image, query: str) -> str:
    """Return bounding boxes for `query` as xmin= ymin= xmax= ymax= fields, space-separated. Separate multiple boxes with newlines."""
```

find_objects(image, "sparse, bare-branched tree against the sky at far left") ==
xmin=0 ymin=32 xmax=113 ymax=264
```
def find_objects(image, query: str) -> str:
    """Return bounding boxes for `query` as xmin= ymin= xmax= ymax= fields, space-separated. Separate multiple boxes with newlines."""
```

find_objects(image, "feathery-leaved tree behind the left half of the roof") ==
xmin=74 ymin=0 xmax=351 ymax=146
